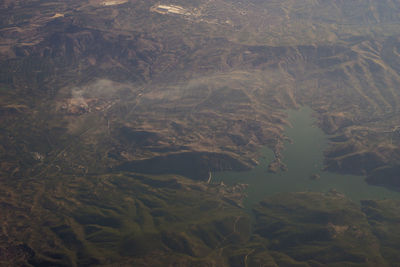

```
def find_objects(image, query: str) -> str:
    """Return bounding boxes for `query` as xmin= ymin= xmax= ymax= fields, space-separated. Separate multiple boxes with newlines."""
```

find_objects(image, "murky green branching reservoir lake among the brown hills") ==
xmin=212 ymin=107 xmax=400 ymax=207
